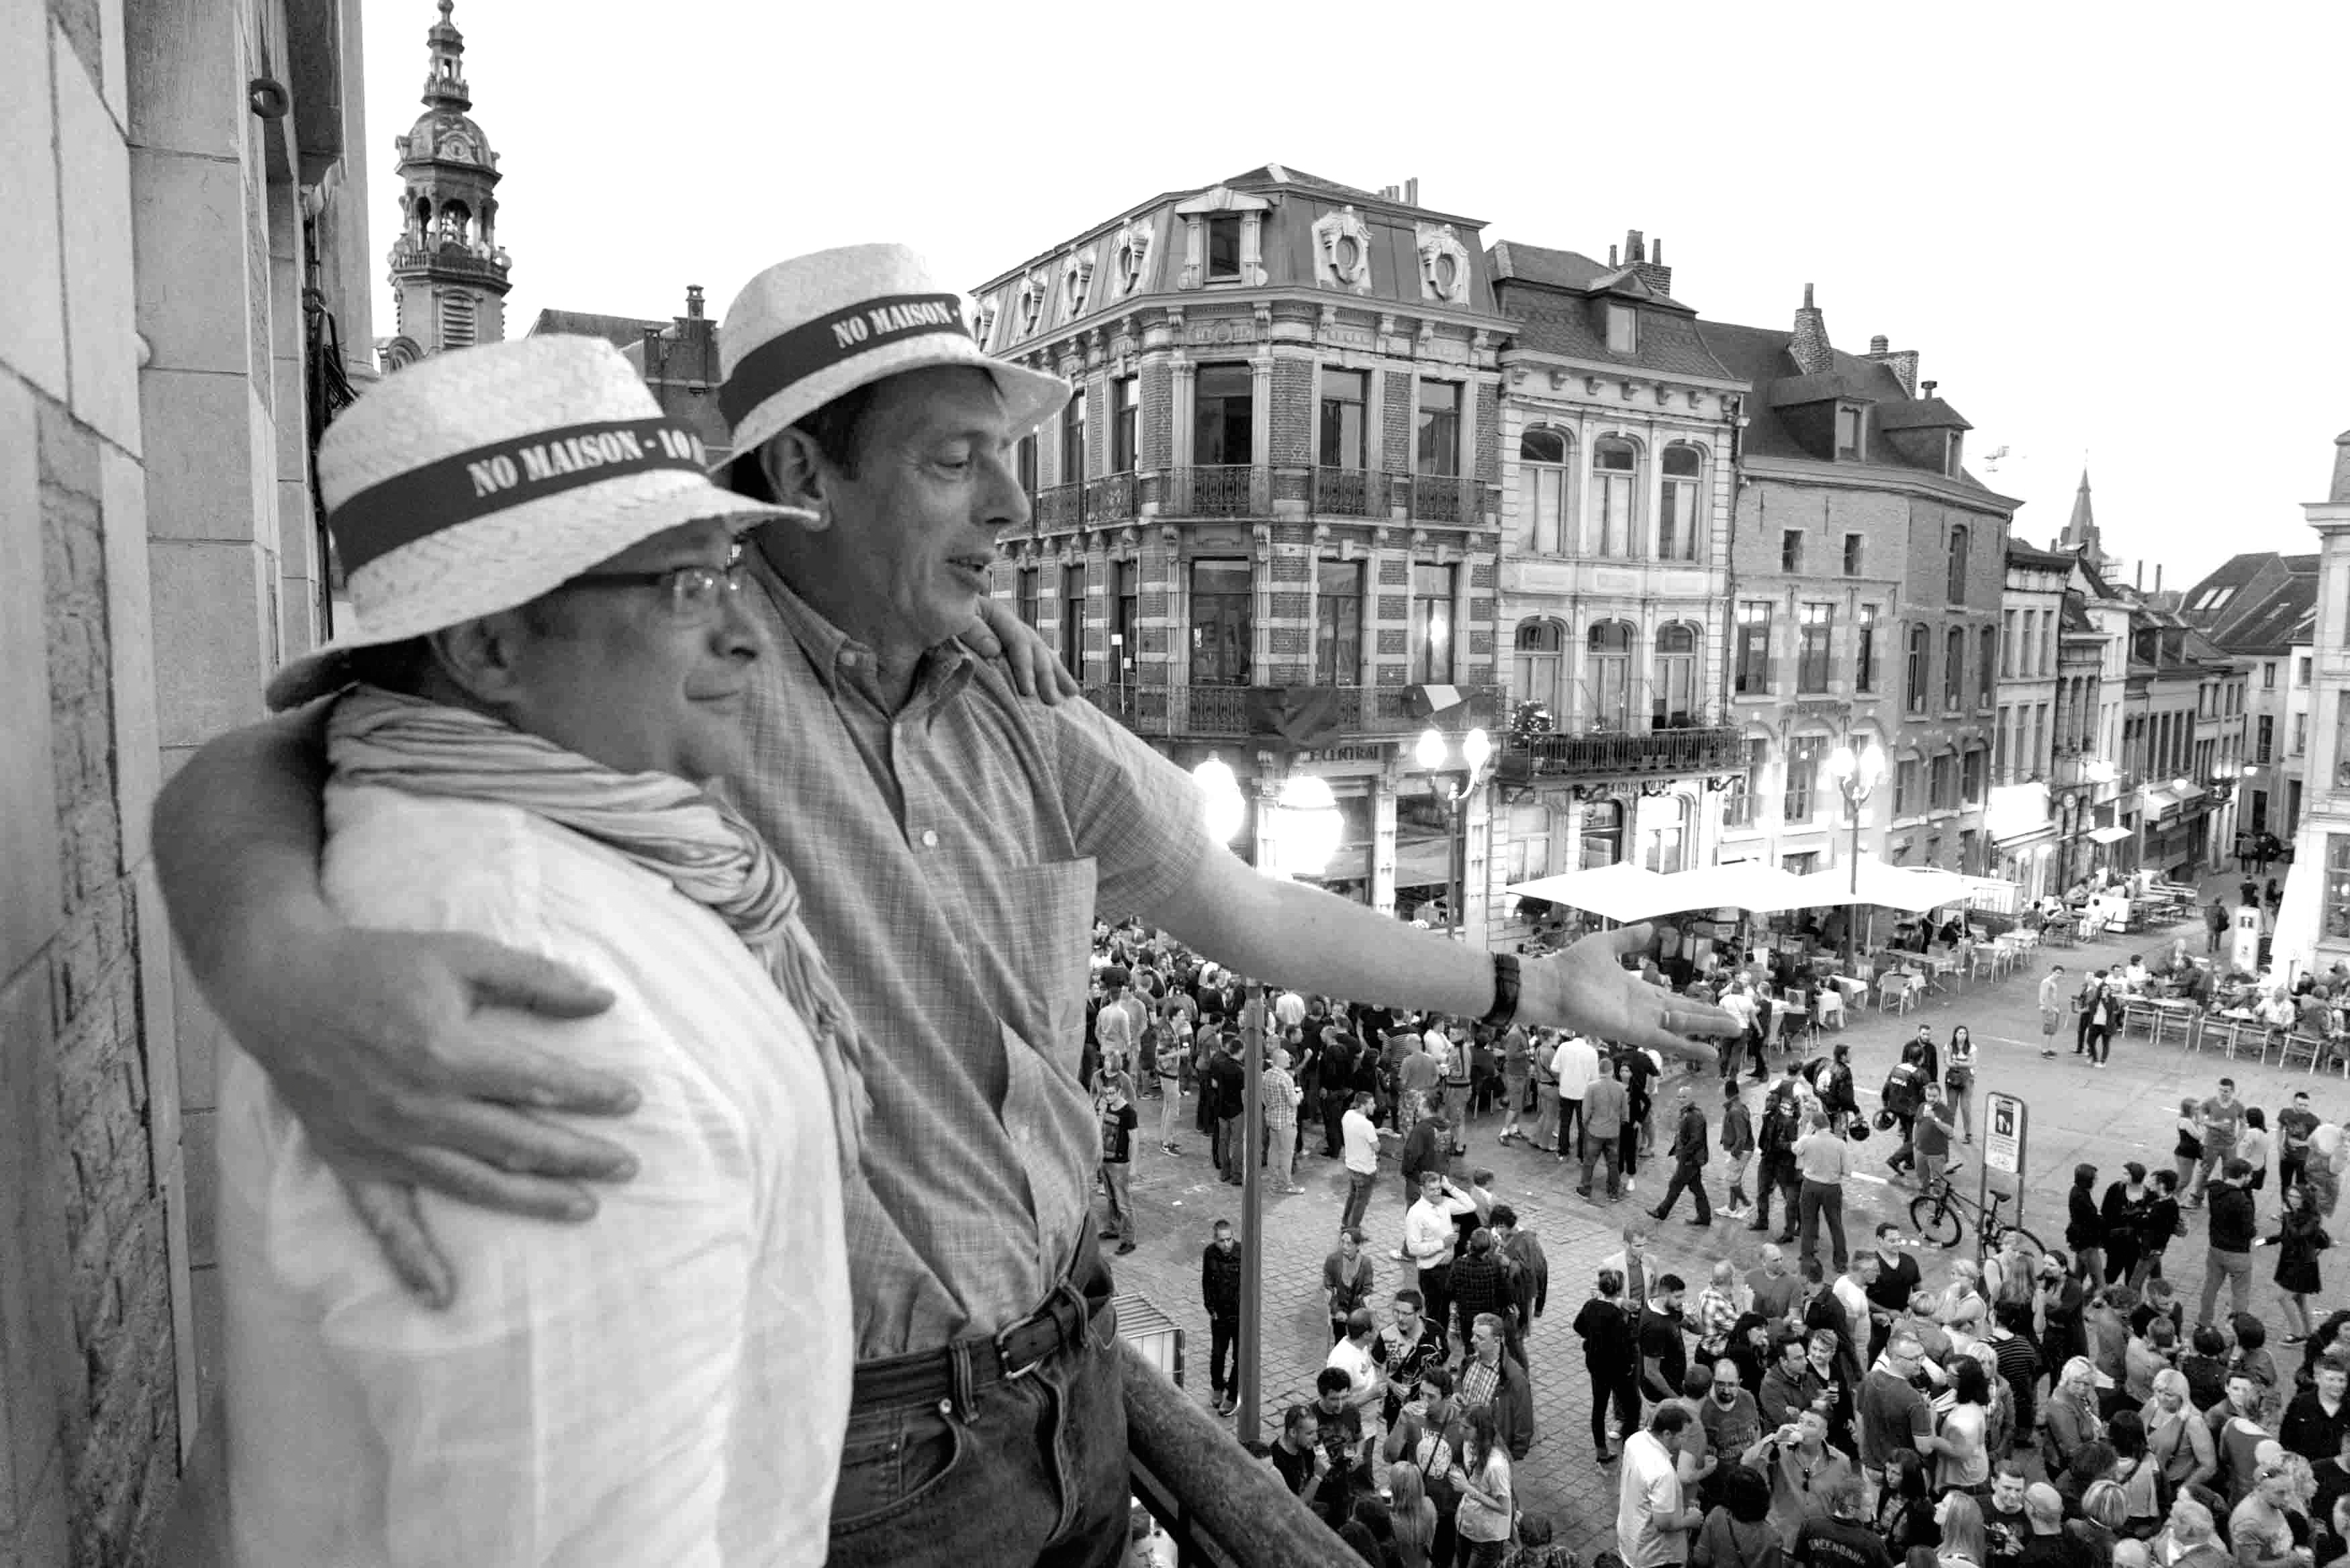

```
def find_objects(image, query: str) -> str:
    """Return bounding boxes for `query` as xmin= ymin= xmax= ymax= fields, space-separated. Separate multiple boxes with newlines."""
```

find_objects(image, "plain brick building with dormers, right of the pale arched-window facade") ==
xmin=1699 ymin=287 xmax=2019 ymax=872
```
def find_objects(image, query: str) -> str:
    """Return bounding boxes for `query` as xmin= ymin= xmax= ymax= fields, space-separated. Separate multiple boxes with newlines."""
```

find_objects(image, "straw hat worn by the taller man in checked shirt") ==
xmin=719 ymin=244 xmax=1070 ymax=456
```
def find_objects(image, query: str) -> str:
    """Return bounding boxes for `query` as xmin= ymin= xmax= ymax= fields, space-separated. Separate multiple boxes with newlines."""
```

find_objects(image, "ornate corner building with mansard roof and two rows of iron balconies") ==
xmin=976 ymin=164 xmax=1509 ymax=938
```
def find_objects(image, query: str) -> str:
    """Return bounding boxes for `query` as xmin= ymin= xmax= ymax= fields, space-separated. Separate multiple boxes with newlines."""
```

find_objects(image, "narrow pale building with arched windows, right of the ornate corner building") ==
xmin=1493 ymin=230 xmax=1746 ymax=902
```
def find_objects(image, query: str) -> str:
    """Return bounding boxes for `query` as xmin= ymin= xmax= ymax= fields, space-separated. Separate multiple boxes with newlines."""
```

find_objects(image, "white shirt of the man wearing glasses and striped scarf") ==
xmin=219 ymin=785 xmax=853 ymax=1568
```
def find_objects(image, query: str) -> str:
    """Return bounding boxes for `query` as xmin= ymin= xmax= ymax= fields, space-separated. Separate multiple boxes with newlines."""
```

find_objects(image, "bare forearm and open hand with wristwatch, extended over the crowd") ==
xmin=1145 ymin=848 xmax=1739 ymax=1061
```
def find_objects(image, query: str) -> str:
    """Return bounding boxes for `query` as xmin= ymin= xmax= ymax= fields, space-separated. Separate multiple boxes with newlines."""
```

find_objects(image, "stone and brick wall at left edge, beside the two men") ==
xmin=0 ymin=0 xmax=371 ymax=1568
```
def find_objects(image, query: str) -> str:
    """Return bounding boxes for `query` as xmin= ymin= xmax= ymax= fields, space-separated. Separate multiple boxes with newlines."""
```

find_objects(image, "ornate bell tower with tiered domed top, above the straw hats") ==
xmin=385 ymin=0 xmax=510 ymax=369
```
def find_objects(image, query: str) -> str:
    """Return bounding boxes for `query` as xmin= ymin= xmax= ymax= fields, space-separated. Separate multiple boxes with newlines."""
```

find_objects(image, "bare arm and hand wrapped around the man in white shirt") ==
xmin=155 ymin=705 xmax=637 ymax=1295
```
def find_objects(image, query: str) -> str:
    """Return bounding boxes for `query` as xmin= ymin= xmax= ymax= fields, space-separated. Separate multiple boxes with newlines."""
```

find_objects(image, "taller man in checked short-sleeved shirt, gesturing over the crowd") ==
xmin=158 ymin=244 xmax=1728 ymax=1563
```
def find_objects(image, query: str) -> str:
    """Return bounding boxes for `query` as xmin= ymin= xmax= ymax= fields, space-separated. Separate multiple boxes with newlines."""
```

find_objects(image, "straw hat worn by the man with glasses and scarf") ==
xmin=268 ymin=336 xmax=804 ymax=707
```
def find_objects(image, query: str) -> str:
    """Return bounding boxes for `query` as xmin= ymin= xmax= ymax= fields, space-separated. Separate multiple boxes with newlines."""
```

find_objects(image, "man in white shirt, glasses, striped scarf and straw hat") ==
xmin=219 ymin=338 xmax=858 ymax=1568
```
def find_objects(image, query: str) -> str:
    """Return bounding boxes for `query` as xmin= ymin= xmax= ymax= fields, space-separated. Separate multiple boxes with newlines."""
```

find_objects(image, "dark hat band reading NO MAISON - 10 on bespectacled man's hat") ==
xmin=327 ymin=418 xmax=705 ymax=571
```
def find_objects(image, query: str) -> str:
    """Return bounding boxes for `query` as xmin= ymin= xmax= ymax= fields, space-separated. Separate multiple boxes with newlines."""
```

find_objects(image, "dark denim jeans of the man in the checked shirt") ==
xmin=830 ymin=1236 xmax=1128 ymax=1568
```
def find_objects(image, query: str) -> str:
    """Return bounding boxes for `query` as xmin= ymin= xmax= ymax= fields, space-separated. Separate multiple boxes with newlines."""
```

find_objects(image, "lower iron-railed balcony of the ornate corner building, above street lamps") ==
xmin=1086 ymin=682 xmax=1499 ymax=748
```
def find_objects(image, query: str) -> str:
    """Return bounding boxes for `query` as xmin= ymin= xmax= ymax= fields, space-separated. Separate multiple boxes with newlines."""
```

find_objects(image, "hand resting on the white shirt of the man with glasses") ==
xmin=219 ymin=928 xmax=637 ymax=1305
